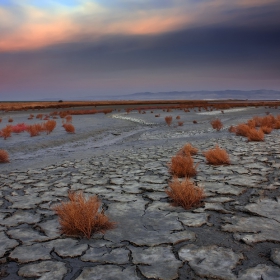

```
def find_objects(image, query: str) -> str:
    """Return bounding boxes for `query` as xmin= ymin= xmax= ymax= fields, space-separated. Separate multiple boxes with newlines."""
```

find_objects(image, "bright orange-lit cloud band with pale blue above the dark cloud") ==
xmin=0 ymin=0 xmax=280 ymax=52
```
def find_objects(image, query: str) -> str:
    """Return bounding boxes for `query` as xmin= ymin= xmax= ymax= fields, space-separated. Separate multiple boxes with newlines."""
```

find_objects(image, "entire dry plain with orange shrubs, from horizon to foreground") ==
xmin=0 ymin=101 xmax=280 ymax=280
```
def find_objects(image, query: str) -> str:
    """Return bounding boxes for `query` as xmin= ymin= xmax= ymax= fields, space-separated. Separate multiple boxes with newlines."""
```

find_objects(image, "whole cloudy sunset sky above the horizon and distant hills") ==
xmin=0 ymin=0 xmax=280 ymax=101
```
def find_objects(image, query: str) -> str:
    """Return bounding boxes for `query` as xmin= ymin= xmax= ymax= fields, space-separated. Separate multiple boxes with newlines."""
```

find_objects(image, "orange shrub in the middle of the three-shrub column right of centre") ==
xmin=169 ymin=154 xmax=197 ymax=177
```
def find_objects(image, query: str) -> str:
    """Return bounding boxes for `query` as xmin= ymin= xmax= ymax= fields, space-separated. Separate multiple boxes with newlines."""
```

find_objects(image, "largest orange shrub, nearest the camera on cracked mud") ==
xmin=53 ymin=192 xmax=116 ymax=239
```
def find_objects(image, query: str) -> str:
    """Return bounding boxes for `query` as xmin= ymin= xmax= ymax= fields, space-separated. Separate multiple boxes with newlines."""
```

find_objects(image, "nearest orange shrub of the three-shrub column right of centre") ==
xmin=165 ymin=178 xmax=205 ymax=209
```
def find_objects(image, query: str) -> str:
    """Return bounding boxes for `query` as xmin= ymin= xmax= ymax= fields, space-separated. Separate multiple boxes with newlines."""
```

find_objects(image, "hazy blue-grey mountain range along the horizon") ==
xmin=41 ymin=89 xmax=280 ymax=101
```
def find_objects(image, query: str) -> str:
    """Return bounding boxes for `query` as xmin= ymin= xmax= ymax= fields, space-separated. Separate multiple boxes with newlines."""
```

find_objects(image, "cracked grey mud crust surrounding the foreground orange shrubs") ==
xmin=0 ymin=106 xmax=280 ymax=280
